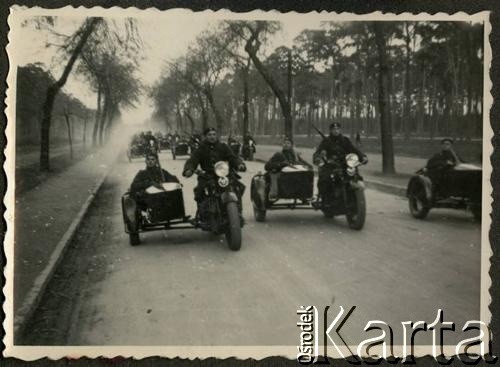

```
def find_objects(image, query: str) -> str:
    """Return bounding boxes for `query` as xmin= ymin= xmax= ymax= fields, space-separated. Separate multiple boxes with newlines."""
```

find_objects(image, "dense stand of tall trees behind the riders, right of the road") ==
xmin=150 ymin=21 xmax=483 ymax=172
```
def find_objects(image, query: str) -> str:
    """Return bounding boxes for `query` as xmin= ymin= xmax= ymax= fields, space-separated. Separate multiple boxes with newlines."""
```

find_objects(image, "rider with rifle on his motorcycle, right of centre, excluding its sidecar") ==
xmin=313 ymin=122 xmax=368 ymax=229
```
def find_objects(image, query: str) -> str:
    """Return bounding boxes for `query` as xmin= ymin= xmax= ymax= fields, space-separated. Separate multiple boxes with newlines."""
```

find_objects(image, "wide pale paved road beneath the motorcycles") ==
xmin=23 ymin=154 xmax=480 ymax=345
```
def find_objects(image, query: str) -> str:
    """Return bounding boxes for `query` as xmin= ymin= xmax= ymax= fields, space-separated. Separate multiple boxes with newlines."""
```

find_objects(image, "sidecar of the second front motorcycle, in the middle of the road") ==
xmin=250 ymin=165 xmax=314 ymax=222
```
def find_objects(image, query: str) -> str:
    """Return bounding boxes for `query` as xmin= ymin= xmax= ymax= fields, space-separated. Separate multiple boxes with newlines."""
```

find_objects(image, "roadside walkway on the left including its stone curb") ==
xmin=10 ymin=152 xmax=115 ymax=343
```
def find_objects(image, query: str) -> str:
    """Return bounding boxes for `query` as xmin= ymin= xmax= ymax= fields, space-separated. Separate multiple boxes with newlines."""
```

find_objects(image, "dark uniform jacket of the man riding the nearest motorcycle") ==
xmin=184 ymin=140 xmax=242 ymax=173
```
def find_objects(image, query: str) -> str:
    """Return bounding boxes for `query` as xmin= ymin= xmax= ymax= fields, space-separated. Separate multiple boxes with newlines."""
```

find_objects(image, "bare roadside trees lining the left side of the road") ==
xmin=18 ymin=17 xmax=142 ymax=171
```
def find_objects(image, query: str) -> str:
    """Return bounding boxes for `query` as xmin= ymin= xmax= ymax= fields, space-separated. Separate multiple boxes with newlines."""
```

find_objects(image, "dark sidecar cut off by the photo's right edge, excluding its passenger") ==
xmin=406 ymin=163 xmax=482 ymax=220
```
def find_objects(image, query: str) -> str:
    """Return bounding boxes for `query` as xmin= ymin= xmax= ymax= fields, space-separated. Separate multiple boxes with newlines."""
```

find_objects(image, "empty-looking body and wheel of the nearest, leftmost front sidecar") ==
xmin=122 ymin=183 xmax=195 ymax=246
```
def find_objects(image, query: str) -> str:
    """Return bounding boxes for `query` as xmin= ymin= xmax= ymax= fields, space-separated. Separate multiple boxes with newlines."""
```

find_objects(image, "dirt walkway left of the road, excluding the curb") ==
xmin=12 ymin=152 xmax=112 ymax=318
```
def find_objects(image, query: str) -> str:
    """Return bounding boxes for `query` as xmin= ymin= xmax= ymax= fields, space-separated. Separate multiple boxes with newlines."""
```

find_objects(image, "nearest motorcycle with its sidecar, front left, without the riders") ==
xmin=122 ymin=161 xmax=243 ymax=251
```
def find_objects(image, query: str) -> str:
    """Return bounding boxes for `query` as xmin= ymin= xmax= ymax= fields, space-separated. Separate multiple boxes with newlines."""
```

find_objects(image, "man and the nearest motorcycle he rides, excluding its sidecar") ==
xmin=183 ymin=128 xmax=246 ymax=251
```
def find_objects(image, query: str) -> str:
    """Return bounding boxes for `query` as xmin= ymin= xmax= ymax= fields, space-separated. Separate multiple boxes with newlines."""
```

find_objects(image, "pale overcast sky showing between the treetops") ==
xmin=16 ymin=13 xmax=320 ymax=123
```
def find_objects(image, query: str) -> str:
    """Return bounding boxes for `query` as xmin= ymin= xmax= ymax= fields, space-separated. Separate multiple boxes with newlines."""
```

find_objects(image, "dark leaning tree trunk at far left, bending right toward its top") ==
xmin=40 ymin=18 xmax=102 ymax=171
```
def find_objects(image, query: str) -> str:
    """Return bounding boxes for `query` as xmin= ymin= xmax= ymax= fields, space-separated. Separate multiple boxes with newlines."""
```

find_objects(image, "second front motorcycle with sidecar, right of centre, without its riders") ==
xmin=250 ymin=154 xmax=366 ymax=230
